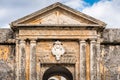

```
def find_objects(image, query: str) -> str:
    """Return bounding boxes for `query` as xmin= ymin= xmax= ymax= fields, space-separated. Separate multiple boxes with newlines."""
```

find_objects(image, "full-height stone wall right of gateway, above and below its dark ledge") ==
xmin=101 ymin=29 xmax=120 ymax=80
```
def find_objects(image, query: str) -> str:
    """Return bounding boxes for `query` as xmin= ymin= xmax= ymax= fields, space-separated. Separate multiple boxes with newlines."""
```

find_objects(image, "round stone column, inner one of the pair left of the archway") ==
xmin=30 ymin=40 xmax=37 ymax=80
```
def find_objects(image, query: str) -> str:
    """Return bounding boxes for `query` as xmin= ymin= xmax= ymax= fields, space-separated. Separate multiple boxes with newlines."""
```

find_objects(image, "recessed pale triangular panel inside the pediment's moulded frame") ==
xmin=20 ymin=10 xmax=96 ymax=25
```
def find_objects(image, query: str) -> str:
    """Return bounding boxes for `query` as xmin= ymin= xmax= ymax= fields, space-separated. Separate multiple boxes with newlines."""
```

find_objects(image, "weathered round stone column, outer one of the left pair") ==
xmin=19 ymin=40 xmax=26 ymax=80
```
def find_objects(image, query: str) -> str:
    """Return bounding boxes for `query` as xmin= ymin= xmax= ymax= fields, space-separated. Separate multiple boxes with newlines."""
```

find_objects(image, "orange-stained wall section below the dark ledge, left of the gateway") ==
xmin=0 ymin=44 xmax=15 ymax=80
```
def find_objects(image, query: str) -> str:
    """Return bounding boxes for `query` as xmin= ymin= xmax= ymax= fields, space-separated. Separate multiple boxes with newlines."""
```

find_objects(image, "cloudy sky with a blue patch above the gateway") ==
xmin=0 ymin=0 xmax=120 ymax=28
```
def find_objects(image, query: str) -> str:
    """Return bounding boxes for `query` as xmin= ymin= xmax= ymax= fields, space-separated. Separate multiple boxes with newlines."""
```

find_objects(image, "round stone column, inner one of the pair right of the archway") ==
xmin=80 ymin=40 xmax=86 ymax=80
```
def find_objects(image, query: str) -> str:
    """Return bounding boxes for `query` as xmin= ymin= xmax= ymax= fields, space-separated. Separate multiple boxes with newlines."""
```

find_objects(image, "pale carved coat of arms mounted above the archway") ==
xmin=52 ymin=41 xmax=65 ymax=61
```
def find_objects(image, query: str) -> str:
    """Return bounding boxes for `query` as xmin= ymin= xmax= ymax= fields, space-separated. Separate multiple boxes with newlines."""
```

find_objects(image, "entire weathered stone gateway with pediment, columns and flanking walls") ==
xmin=0 ymin=2 xmax=120 ymax=80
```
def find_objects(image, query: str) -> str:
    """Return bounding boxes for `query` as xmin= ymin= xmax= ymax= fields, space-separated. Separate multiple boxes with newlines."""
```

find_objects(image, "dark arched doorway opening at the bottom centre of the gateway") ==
xmin=42 ymin=66 xmax=73 ymax=80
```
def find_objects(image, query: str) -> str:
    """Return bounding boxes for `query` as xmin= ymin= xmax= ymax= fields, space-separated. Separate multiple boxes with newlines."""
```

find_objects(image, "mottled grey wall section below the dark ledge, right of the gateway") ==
xmin=101 ymin=45 xmax=120 ymax=80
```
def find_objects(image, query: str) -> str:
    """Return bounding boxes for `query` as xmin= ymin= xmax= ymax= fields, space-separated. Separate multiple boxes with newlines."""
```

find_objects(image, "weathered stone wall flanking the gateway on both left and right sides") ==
xmin=0 ymin=29 xmax=120 ymax=80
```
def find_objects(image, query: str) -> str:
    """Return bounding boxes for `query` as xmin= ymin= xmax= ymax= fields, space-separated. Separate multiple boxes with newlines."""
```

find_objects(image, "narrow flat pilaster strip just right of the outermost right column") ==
xmin=96 ymin=40 xmax=101 ymax=80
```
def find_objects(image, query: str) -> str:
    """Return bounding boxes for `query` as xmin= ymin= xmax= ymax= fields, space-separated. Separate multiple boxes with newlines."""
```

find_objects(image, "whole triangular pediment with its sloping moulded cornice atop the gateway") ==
xmin=12 ymin=3 xmax=106 ymax=27
